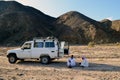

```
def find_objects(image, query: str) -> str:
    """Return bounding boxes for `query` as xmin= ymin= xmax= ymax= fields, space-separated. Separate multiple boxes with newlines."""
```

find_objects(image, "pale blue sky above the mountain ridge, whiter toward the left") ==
xmin=13 ymin=0 xmax=120 ymax=21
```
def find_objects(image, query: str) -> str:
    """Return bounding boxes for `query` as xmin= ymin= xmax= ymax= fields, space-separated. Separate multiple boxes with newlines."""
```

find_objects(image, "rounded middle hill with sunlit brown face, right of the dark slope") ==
xmin=56 ymin=11 xmax=109 ymax=44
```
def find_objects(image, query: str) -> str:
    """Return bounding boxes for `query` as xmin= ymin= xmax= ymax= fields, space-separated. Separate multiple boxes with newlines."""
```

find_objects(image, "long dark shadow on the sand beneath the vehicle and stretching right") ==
xmin=17 ymin=60 xmax=120 ymax=71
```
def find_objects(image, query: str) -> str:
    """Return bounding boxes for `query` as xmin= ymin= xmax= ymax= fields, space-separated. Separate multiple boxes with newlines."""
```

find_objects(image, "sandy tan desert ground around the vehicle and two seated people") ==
xmin=0 ymin=46 xmax=120 ymax=80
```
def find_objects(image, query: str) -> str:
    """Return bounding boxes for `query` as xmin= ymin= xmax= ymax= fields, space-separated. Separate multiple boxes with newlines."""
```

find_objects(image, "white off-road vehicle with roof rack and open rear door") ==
xmin=7 ymin=37 xmax=69 ymax=64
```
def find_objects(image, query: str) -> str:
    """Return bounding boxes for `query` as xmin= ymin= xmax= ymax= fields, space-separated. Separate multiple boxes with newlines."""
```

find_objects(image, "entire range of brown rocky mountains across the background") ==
xmin=0 ymin=1 xmax=120 ymax=45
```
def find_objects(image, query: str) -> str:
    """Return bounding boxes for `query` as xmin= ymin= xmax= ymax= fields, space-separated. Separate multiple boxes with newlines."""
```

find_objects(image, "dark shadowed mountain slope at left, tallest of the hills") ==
xmin=0 ymin=1 xmax=54 ymax=45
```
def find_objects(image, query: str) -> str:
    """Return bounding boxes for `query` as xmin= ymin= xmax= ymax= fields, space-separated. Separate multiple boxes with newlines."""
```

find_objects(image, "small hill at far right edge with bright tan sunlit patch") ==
xmin=101 ymin=19 xmax=120 ymax=43
